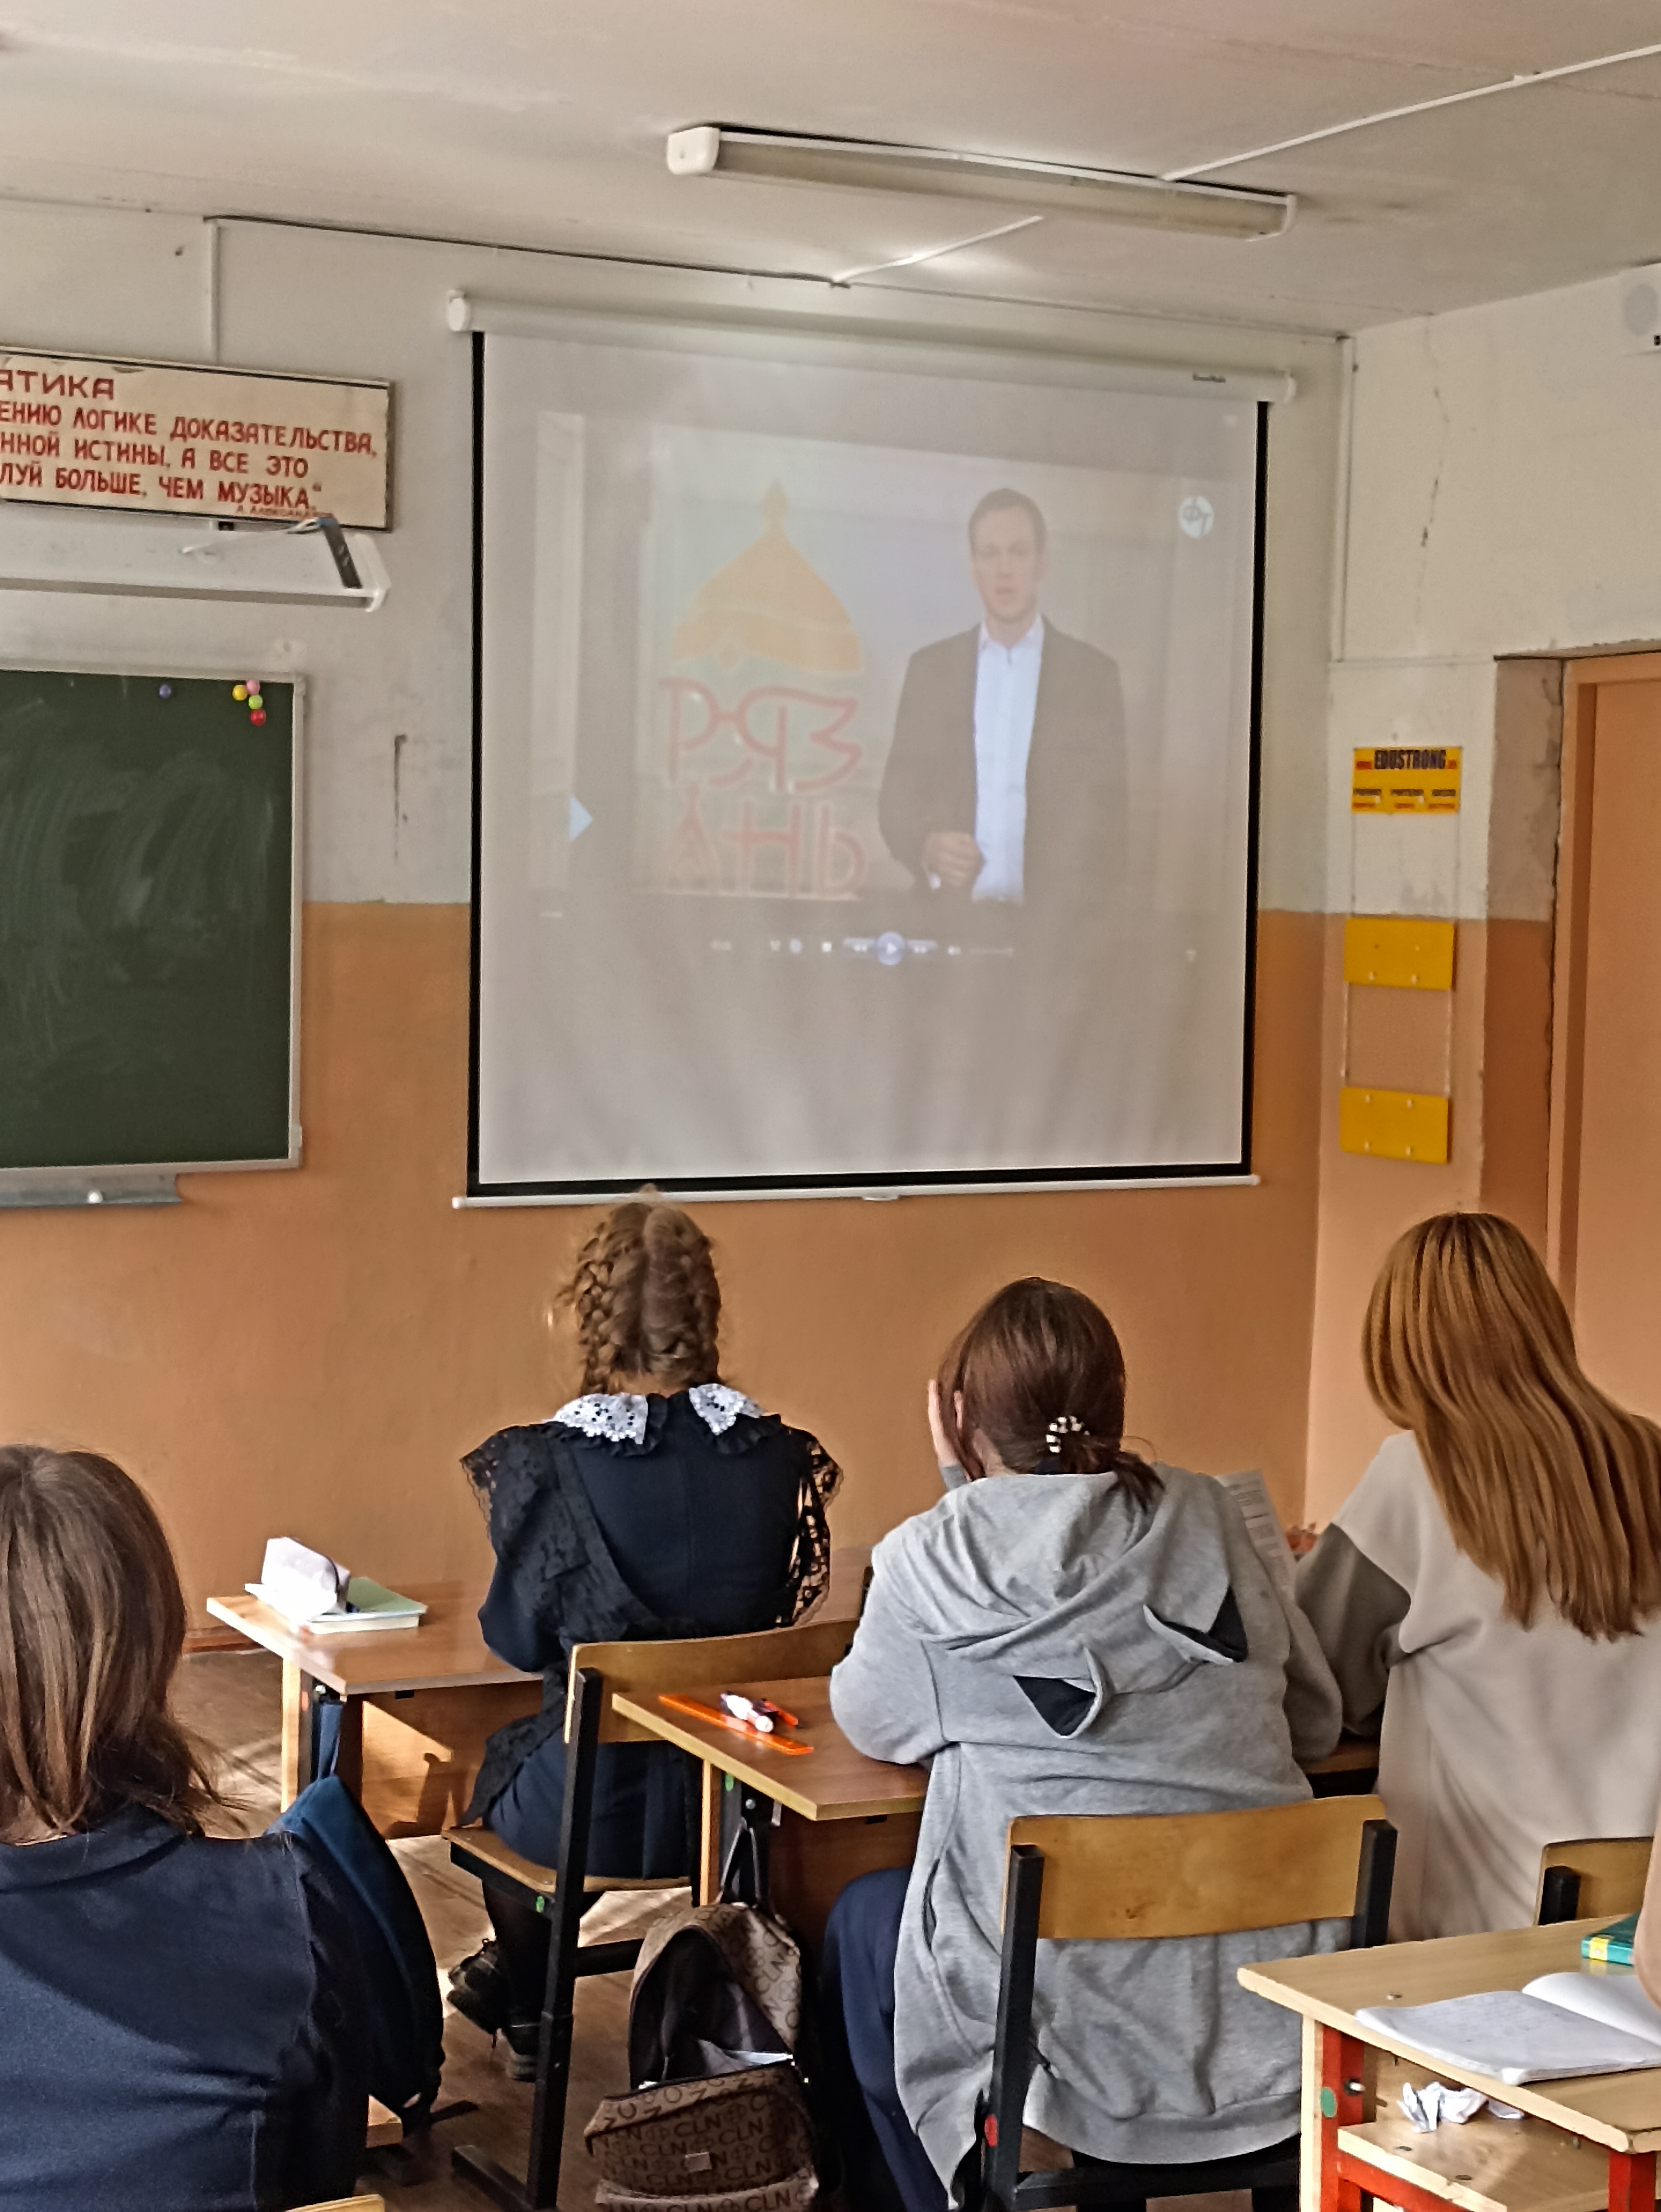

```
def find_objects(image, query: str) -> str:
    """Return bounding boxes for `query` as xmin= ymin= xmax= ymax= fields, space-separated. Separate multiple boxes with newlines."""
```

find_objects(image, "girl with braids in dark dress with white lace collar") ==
xmin=451 ymin=1194 xmax=841 ymax=2079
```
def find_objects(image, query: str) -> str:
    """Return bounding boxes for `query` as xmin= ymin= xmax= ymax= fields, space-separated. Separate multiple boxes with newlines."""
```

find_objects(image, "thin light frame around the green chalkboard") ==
xmin=0 ymin=655 xmax=308 ymax=1208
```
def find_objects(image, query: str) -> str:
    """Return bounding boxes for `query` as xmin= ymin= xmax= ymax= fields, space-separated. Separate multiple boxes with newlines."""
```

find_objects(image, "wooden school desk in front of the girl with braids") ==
xmin=208 ymin=1582 xmax=542 ymax=1836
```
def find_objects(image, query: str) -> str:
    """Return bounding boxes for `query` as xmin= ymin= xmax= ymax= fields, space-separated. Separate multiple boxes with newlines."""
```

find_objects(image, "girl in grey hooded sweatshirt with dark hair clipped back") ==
xmin=827 ymin=1276 xmax=1347 ymax=2212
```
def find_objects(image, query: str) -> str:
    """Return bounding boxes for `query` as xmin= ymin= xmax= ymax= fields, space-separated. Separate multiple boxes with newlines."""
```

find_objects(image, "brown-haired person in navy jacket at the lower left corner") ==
xmin=0 ymin=1444 xmax=369 ymax=2212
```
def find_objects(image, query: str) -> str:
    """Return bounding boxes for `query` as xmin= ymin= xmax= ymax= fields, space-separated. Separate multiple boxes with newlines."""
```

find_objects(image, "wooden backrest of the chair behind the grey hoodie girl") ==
xmin=1008 ymin=1796 xmax=1394 ymax=1942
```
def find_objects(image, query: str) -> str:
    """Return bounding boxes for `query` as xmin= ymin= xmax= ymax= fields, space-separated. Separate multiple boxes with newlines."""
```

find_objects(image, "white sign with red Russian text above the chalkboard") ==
xmin=0 ymin=352 xmax=391 ymax=531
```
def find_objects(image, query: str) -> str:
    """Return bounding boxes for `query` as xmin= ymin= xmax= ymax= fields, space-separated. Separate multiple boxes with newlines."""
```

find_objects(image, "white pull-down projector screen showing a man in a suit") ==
xmin=469 ymin=323 xmax=1267 ymax=1199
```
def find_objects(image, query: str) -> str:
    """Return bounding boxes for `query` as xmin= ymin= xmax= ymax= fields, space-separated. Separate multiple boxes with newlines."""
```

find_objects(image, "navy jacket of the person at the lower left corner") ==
xmin=0 ymin=1805 xmax=369 ymax=2212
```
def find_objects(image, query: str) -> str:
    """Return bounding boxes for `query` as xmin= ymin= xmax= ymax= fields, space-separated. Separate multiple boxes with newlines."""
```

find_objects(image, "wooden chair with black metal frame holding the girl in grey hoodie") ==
xmin=971 ymin=1796 xmax=1395 ymax=2212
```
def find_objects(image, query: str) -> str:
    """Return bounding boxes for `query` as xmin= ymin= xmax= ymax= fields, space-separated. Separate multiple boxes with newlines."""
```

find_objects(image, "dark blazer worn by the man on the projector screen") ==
xmin=878 ymin=621 xmax=1128 ymax=907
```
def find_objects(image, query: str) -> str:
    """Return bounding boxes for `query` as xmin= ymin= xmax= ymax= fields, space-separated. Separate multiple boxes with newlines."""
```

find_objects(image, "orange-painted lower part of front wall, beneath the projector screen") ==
xmin=0 ymin=905 xmax=1323 ymax=1604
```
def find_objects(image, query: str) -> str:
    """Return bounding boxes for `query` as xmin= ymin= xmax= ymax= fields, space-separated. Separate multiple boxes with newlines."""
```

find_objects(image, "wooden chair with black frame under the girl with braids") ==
xmin=444 ymin=1619 xmax=854 ymax=2212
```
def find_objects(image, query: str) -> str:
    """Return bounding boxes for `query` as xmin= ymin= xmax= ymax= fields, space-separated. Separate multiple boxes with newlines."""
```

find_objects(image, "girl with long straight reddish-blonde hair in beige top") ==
xmin=1298 ymin=1215 xmax=1661 ymax=1938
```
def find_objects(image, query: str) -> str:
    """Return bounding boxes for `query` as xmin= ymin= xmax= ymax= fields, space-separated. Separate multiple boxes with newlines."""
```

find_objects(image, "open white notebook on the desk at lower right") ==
xmin=1356 ymin=1973 xmax=1661 ymax=2084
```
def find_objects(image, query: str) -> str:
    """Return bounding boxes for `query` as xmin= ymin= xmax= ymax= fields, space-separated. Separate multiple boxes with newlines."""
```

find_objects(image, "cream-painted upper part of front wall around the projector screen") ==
xmin=0 ymin=201 xmax=1340 ymax=911
